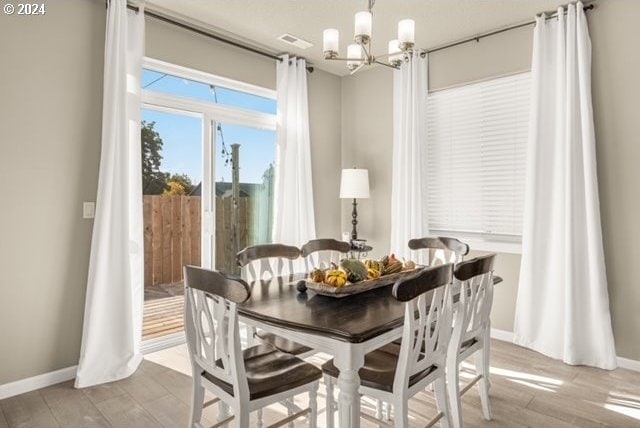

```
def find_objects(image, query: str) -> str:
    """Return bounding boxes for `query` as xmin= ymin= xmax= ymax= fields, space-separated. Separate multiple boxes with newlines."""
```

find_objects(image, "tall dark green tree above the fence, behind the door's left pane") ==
xmin=141 ymin=120 xmax=169 ymax=195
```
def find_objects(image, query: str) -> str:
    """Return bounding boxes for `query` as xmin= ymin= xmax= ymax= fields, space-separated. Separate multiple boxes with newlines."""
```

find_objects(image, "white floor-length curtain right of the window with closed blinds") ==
xmin=514 ymin=3 xmax=616 ymax=369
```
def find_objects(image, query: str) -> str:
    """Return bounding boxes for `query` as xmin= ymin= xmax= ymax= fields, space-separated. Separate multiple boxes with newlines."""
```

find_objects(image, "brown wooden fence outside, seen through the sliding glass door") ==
xmin=143 ymin=195 xmax=259 ymax=287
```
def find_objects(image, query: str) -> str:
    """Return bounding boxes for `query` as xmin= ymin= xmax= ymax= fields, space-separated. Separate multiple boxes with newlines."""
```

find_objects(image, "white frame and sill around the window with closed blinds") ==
xmin=425 ymin=70 xmax=531 ymax=254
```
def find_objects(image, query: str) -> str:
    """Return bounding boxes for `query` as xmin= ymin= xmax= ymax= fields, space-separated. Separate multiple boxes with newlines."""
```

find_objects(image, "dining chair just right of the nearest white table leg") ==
xmin=322 ymin=264 xmax=453 ymax=428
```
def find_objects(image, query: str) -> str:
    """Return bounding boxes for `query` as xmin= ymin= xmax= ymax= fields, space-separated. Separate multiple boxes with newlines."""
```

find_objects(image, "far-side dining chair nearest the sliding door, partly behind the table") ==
xmin=236 ymin=244 xmax=313 ymax=356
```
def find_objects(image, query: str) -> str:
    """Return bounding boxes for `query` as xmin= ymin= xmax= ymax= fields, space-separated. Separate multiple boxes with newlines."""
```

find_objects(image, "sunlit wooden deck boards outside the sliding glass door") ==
xmin=142 ymin=284 xmax=184 ymax=340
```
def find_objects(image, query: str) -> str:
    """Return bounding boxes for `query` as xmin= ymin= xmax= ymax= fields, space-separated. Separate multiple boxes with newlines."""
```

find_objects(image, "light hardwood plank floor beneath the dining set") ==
xmin=0 ymin=341 xmax=640 ymax=428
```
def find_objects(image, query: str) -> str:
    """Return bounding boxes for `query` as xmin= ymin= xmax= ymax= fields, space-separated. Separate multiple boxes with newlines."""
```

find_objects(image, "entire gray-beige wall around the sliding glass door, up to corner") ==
xmin=0 ymin=0 xmax=341 ymax=385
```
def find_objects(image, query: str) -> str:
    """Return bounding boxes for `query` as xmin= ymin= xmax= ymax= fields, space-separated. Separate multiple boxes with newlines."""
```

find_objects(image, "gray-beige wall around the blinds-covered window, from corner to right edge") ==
xmin=342 ymin=0 xmax=640 ymax=360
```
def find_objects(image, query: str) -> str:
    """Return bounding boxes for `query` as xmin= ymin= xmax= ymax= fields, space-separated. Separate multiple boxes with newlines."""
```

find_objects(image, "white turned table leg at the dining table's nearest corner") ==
xmin=334 ymin=345 xmax=364 ymax=428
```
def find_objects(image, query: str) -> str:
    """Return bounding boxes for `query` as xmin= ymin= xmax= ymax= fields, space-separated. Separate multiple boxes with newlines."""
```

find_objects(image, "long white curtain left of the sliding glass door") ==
xmin=75 ymin=0 xmax=144 ymax=388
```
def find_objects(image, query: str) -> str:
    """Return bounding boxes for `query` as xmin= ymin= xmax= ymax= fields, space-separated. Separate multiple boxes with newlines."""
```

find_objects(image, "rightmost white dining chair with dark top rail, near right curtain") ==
xmin=447 ymin=254 xmax=495 ymax=428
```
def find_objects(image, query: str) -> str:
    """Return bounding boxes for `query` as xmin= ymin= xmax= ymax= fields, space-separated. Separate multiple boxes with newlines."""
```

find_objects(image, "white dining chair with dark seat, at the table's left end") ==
xmin=184 ymin=266 xmax=322 ymax=428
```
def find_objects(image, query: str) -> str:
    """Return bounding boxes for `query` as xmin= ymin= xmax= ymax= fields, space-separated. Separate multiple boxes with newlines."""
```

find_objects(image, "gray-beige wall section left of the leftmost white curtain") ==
xmin=0 ymin=0 xmax=105 ymax=384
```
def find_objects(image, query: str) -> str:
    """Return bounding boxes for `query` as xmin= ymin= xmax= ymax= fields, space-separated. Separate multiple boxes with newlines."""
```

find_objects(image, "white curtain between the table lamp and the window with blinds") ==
xmin=391 ymin=53 xmax=428 ymax=263
